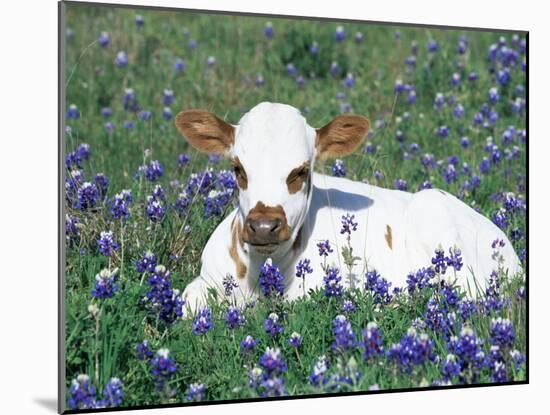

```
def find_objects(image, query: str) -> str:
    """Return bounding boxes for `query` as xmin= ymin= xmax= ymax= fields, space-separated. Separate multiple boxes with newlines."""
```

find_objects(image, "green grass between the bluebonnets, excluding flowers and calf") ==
xmin=64 ymin=4 xmax=526 ymax=412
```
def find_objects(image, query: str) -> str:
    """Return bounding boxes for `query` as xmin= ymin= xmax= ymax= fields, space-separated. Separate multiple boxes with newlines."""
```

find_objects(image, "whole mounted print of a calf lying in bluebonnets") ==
xmin=59 ymin=1 xmax=528 ymax=413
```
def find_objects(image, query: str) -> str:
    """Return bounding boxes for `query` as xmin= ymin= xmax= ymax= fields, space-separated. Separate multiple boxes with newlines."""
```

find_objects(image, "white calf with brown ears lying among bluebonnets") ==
xmin=176 ymin=102 xmax=521 ymax=309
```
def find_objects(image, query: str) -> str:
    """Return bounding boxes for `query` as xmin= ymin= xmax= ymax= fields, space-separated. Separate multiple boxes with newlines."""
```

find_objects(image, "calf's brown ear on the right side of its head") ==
xmin=315 ymin=114 xmax=369 ymax=160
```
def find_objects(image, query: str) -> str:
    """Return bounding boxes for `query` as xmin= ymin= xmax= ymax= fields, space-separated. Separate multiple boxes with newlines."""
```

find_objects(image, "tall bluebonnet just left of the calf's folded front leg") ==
xmin=144 ymin=265 xmax=185 ymax=324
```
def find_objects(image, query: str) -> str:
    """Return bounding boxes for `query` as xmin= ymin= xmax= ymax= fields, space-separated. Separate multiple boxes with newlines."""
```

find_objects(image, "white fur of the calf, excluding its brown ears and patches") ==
xmin=184 ymin=103 xmax=521 ymax=309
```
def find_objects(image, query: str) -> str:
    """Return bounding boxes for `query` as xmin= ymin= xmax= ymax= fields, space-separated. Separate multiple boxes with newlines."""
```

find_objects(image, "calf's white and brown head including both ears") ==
xmin=176 ymin=102 xmax=369 ymax=255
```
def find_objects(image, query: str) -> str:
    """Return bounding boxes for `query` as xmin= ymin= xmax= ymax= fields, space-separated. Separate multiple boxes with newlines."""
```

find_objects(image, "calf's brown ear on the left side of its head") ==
xmin=175 ymin=110 xmax=235 ymax=155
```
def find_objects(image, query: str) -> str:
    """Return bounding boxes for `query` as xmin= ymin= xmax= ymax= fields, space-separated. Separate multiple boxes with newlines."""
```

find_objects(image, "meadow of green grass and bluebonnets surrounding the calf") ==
xmin=62 ymin=4 xmax=527 ymax=409
